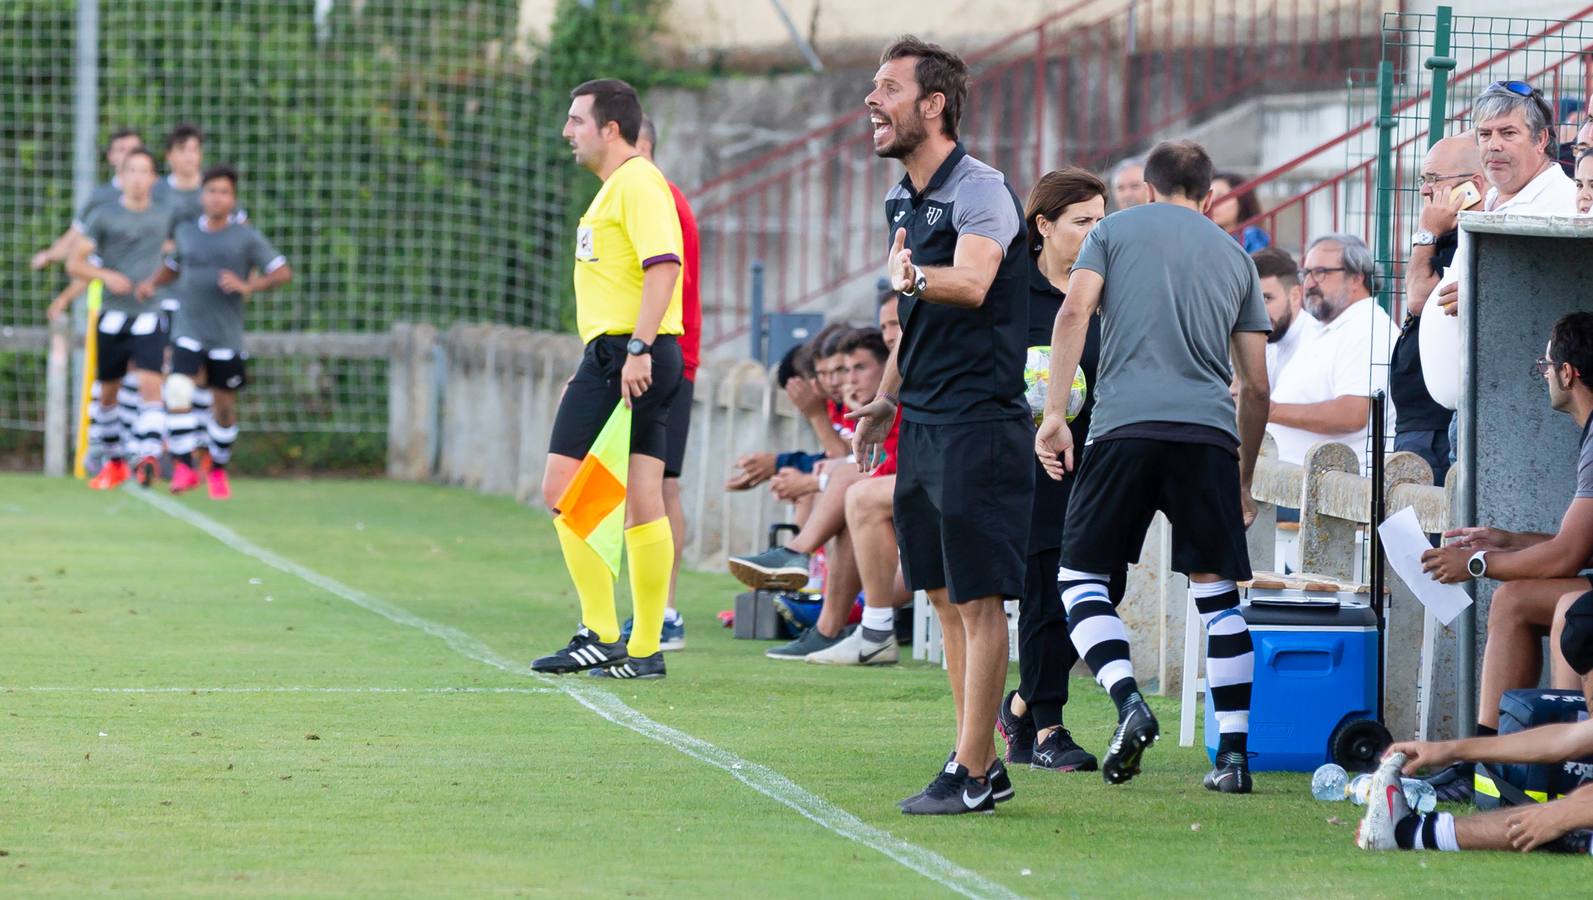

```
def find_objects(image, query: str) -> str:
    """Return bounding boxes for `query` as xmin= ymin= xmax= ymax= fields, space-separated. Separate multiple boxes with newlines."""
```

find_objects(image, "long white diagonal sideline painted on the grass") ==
xmin=126 ymin=486 xmax=1018 ymax=898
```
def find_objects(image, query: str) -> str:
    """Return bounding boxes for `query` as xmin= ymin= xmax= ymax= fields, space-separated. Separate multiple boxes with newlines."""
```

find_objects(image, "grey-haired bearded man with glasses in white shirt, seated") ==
xmin=1266 ymin=234 xmax=1394 ymax=468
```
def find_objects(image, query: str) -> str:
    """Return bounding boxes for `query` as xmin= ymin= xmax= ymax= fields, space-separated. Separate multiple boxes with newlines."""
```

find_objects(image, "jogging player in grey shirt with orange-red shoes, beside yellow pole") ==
xmin=67 ymin=147 xmax=172 ymax=491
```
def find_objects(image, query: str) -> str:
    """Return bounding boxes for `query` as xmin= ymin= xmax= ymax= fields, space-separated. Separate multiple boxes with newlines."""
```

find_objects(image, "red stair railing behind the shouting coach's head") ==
xmin=693 ymin=0 xmax=1388 ymax=347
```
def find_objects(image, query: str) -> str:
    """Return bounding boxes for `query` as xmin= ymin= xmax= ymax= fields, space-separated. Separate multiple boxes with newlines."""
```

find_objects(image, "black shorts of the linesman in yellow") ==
xmin=548 ymin=335 xmax=685 ymax=459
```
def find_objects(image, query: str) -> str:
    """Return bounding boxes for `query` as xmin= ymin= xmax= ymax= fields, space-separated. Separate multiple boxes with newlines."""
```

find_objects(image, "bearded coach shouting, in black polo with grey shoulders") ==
xmin=852 ymin=37 xmax=1038 ymax=816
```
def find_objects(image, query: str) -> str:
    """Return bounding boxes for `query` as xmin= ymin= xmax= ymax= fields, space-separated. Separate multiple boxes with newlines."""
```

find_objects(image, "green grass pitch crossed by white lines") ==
xmin=0 ymin=476 xmax=1593 ymax=897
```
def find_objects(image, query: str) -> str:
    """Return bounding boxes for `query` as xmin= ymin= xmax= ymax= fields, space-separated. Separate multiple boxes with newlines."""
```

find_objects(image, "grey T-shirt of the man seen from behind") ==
xmin=1074 ymin=202 xmax=1273 ymax=446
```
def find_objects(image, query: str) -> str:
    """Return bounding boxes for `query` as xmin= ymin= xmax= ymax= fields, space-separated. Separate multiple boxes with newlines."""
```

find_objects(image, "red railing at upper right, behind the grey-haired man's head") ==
xmin=1217 ymin=6 xmax=1593 ymax=274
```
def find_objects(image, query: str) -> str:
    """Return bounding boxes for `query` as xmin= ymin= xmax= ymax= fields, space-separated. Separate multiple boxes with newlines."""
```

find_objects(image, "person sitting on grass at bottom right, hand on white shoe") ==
xmin=1356 ymin=593 xmax=1593 ymax=854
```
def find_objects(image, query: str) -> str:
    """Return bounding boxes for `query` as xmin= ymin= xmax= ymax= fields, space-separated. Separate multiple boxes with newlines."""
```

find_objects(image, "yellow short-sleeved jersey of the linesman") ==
xmin=575 ymin=156 xmax=685 ymax=344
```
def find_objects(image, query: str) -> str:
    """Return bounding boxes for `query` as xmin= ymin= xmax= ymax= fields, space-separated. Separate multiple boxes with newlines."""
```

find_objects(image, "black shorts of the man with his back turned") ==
xmin=1063 ymin=438 xmax=1251 ymax=581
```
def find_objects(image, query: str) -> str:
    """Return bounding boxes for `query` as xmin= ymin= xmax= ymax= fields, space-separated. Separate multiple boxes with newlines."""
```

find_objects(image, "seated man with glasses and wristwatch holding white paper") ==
xmin=1421 ymin=312 xmax=1593 ymax=800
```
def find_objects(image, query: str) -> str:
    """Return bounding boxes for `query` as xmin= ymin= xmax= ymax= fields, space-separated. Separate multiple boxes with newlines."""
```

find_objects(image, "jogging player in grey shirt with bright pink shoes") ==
xmin=139 ymin=166 xmax=293 ymax=500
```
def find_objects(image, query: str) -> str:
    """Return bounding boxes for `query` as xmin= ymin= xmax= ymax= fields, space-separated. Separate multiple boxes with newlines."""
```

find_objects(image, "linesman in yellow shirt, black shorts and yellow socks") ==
xmin=530 ymin=78 xmax=685 ymax=679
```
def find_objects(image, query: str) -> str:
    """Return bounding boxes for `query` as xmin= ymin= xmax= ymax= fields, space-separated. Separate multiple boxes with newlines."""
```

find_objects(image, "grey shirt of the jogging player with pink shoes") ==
xmin=166 ymin=218 xmax=287 ymax=352
